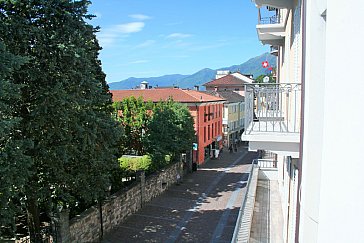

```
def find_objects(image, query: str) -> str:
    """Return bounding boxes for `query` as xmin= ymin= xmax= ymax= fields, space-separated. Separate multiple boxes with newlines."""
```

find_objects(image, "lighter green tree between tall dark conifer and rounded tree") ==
xmin=113 ymin=96 xmax=153 ymax=155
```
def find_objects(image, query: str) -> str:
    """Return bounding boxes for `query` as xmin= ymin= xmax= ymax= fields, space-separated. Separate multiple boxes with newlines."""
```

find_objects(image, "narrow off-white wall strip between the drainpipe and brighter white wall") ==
xmin=299 ymin=0 xmax=326 ymax=243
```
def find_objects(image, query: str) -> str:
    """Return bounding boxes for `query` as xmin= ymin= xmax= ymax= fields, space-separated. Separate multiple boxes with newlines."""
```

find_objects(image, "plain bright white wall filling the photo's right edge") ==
xmin=318 ymin=0 xmax=364 ymax=242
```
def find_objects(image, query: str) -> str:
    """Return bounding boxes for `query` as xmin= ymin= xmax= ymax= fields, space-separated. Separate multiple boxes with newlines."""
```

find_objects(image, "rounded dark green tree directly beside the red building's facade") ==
xmin=148 ymin=99 xmax=195 ymax=167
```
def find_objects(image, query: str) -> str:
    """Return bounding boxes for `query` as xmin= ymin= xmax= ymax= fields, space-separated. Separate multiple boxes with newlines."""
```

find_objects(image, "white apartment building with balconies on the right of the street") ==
xmin=242 ymin=0 xmax=364 ymax=243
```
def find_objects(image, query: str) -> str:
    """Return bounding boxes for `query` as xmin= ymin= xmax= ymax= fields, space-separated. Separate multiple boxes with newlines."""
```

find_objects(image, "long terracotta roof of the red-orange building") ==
xmin=110 ymin=88 xmax=225 ymax=103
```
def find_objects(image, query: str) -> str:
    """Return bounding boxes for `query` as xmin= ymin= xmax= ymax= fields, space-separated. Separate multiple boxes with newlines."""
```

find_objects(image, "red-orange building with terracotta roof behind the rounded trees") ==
xmin=110 ymin=88 xmax=225 ymax=164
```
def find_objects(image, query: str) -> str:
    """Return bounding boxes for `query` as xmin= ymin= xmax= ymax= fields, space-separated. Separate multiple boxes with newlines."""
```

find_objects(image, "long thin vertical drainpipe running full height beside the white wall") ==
xmin=295 ymin=0 xmax=307 ymax=243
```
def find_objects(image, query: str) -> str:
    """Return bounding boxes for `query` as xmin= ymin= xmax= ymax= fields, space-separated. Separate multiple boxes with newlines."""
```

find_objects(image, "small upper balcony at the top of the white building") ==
xmin=256 ymin=9 xmax=288 ymax=46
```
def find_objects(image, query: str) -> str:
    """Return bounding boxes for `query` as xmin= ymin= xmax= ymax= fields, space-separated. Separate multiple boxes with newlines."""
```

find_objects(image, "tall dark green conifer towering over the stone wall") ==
xmin=0 ymin=0 xmax=120 ymax=239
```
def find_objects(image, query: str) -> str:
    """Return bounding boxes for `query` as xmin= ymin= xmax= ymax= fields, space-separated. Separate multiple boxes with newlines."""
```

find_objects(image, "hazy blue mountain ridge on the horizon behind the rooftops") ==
xmin=109 ymin=53 xmax=276 ymax=90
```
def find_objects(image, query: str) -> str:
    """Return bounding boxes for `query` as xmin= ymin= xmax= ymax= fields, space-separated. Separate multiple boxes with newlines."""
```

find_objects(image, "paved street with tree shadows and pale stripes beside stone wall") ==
xmin=103 ymin=147 xmax=256 ymax=243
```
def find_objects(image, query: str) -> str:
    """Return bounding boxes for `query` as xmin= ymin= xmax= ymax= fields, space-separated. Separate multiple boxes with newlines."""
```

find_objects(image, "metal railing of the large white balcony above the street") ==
xmin=244 ymin=83 xmax=301 ymax=135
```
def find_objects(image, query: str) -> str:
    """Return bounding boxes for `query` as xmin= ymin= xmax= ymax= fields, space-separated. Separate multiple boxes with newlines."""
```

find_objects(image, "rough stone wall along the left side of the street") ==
xmin=69 ymin=163 xmax=182 ymax=242
